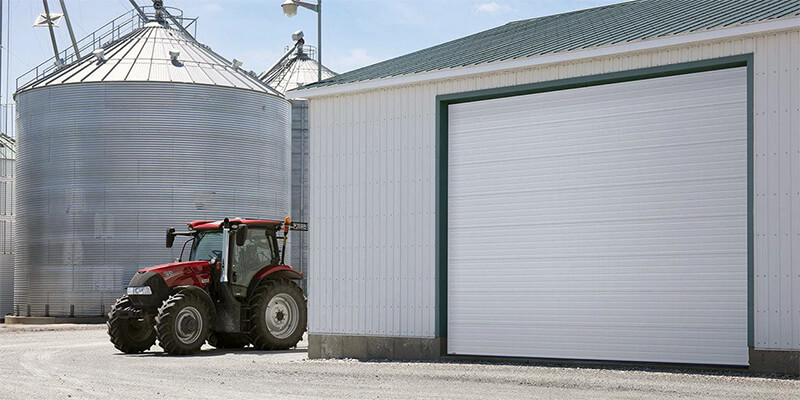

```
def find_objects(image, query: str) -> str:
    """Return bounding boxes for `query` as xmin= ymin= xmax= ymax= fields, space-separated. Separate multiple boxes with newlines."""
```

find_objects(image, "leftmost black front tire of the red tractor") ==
xmin=106 ymin=296 xmax=156 ymax=354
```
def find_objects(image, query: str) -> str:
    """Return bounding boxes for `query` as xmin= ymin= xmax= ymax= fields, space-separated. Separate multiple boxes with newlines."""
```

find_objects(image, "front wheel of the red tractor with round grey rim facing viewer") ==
xmin=156 ymin=292 xmax=211 ymax=355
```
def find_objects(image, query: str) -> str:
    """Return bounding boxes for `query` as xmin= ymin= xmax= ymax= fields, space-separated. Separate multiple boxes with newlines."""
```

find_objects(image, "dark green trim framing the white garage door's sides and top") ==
xmin=435 ymin=53 xmax=755 ymax=355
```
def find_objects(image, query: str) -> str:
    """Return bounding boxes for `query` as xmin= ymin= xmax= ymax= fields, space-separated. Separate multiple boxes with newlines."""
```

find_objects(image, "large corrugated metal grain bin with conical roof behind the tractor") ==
xmin=15 ymin=22 xmax=291 ymax=316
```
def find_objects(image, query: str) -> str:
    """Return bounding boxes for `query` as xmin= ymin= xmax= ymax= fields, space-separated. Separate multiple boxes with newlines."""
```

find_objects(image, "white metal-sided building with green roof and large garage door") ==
xmin=289 ymin=0 xmax=800 ymax=373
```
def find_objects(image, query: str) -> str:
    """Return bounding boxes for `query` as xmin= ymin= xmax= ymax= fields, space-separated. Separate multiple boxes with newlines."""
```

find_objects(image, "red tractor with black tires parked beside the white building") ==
xmin=107 ymin=218 xmax=306 ymax=354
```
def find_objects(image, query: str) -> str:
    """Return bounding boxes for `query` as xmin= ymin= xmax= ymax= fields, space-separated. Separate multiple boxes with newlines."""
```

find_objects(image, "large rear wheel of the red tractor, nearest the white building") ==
xmin=249 ymin=280 xmax=307 ymax=350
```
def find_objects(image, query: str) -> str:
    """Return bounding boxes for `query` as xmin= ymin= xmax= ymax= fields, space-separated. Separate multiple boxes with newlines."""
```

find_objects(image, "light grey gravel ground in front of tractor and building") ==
xmin=0 ymin=325 xmax=800 ymax=400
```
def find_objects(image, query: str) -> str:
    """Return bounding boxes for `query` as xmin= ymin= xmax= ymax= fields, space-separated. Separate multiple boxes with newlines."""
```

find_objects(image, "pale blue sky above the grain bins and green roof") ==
xmin=3 ymin=0 xmax=619 ymax=102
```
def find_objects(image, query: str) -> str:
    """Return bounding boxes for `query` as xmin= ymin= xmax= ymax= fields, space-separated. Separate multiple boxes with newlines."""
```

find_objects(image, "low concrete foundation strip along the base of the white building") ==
xmin=308 ymin=334 xmax=800 ymax=376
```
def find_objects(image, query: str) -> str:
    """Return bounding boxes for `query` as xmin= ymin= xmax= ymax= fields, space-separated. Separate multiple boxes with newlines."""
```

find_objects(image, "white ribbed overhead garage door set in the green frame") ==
xmin=447 ymin=68 xmax=748 ymax=365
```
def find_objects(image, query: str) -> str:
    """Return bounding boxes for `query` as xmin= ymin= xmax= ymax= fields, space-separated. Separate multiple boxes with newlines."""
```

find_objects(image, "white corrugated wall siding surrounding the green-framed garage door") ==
xmin=309 ymin=29 xmax=800 ymax=349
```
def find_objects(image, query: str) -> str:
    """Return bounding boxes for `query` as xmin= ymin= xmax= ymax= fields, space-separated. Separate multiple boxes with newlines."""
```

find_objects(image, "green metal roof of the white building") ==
xmin=303 ymin=0 xmax=800 ymax=88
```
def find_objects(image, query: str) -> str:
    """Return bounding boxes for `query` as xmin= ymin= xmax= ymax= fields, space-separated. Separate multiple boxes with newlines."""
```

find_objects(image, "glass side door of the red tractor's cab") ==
xmin=230 ymin=228 xmax=276 ymax=297
